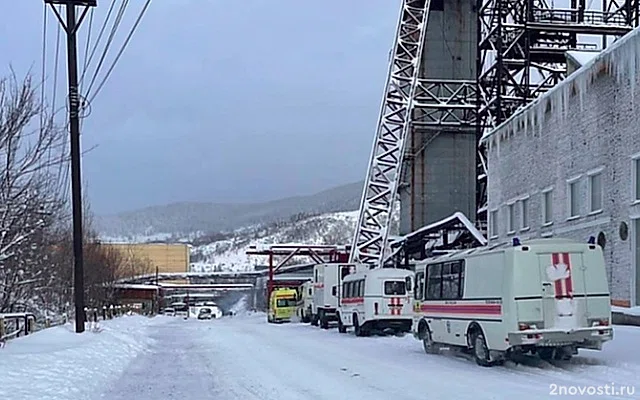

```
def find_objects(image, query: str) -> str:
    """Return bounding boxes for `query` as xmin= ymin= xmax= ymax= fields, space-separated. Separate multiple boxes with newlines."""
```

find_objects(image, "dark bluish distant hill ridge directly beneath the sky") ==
xmin=95 ymin=182 xmax=364 ymax=241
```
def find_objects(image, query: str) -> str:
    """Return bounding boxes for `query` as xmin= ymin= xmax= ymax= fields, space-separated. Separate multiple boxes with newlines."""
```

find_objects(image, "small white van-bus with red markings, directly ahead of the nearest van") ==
xmin=338 ymin=268 xmax=414 ymax=336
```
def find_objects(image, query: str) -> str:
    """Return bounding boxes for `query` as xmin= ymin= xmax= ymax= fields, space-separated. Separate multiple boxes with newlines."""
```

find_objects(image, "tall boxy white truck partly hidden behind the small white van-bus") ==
xmin=311 ymin=264 xmax=370 ymax=329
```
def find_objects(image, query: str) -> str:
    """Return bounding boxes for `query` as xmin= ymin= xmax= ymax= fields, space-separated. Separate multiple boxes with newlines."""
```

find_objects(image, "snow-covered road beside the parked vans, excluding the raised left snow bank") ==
xmin=101 ymin=314 xmax=640 ymax=400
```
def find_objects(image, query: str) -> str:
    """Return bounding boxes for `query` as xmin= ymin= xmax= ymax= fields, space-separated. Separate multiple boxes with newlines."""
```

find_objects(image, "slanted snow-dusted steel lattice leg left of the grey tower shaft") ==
xmin=349 ymin=0 xmax=431 ymax=267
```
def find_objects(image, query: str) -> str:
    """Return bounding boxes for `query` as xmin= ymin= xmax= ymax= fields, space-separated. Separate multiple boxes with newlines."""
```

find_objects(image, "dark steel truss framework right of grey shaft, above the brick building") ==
xmin=476 ymin=0 xmax=640 ymax=221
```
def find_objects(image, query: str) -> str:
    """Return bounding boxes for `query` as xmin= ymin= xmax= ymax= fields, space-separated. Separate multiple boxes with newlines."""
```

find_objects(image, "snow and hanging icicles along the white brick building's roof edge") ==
xmin=481 ymin=27 xmax=640 ymax=143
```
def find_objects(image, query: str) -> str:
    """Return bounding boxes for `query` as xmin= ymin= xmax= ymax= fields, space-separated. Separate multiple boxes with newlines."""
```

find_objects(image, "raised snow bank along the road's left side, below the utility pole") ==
xmin=0 ymin=316 xmax=170 ymax=400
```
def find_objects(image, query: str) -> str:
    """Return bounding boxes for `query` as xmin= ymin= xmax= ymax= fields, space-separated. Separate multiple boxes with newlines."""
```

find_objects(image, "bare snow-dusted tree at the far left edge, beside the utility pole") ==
xmin=0 ymin=74 xmax=66 ymax=312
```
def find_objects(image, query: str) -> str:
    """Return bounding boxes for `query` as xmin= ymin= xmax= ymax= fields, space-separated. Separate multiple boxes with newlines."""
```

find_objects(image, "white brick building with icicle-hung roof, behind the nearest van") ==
xmin=482 ymin=29 xmax=640 ymax=306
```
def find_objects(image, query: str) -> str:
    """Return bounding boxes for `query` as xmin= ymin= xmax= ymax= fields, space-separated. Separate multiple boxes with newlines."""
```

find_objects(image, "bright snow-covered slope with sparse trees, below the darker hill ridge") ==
xmin=191 ymin=211 xmax=358 ymax=272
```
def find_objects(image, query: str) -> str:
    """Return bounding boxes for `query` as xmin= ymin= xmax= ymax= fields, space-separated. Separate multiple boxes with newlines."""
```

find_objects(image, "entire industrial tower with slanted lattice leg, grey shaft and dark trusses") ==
xmin=350 ymin=0 xmax=640 ymax=266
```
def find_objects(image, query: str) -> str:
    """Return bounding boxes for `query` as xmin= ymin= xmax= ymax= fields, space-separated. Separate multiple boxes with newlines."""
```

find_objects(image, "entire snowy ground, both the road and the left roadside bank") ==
xmin=0 ymin=314 xmax=640 ymax=400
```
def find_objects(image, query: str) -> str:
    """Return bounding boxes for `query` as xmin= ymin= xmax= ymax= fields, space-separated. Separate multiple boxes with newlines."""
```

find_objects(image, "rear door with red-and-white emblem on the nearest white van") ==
xmin=538 ymin=252 xmax=588 ymax=329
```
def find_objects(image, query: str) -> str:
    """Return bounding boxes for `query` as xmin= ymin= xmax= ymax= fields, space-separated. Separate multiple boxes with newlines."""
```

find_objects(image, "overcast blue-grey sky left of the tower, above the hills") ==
xmin=0 ymin=0 xmax=399 ymax=214
